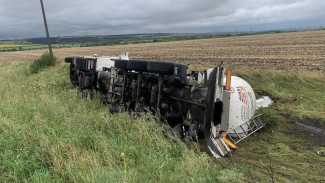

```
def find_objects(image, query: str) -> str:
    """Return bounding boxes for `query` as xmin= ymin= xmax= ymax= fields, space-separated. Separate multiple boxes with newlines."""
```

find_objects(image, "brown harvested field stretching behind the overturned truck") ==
xmin=0 ymin=30 xmax=325 ymax=73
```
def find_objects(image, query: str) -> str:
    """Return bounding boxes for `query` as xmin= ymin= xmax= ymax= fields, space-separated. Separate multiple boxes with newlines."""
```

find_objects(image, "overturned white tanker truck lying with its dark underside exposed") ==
xmin=65 ymin=53 xmax=263 ymax=158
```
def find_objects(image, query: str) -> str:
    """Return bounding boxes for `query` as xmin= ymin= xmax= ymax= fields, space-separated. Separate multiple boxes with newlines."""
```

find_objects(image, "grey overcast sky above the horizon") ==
xmin=0 ymin=0 xmax=325 ymax=39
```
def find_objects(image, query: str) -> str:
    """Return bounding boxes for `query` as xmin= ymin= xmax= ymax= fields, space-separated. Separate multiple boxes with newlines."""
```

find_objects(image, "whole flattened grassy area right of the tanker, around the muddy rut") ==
xmin=233 ymin=71 xmax=325 ymax=182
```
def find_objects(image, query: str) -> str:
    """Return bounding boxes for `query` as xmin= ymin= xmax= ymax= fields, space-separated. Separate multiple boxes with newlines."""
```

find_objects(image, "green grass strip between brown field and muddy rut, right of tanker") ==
xmin=238 ymin=70 xmax=325 ymax=125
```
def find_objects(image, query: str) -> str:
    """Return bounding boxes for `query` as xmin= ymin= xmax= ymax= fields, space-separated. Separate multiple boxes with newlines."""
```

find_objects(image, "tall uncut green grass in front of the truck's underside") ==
xmin=0 ymin=62 xmax=244 ymax=182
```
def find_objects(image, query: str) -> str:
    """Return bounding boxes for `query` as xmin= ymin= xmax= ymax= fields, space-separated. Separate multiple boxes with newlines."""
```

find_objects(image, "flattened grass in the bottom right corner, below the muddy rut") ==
xmin=233 ymin=129 xmax=325 ymax=182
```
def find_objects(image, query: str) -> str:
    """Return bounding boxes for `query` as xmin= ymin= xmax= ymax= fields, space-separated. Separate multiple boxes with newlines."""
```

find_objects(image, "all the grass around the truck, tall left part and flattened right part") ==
xmin=0 ymin=62 xmax=325 ymax=182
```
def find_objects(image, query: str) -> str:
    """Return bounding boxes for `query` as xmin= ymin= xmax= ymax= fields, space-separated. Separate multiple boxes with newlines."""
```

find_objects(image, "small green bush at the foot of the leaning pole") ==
xmin=29 ymin=52 xmax=56 ymax=74
